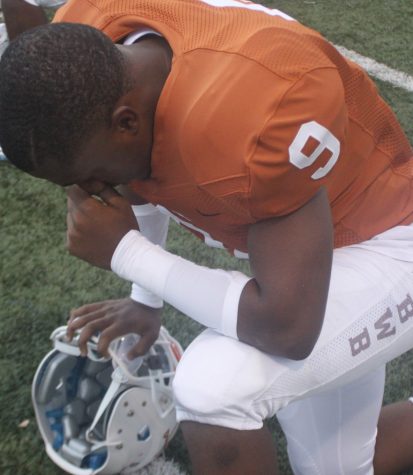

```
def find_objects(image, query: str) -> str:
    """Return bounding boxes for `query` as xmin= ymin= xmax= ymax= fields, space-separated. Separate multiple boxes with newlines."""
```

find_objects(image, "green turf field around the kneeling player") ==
xmin=0 ymin=0 xmax=413 ymax=475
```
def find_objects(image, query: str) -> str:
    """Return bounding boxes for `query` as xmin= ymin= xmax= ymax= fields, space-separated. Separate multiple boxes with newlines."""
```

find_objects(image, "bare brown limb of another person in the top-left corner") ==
xmin=1 ymin=0 xmax=47 ymax=40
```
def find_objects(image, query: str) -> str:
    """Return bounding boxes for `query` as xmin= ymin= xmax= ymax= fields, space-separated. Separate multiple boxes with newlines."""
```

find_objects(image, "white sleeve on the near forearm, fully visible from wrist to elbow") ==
xmin=111 ymin=230 xmax=250 ymax=338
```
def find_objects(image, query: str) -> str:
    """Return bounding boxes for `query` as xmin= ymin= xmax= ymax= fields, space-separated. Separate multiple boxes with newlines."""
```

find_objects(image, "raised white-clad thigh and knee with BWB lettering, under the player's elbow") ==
xmin=174 ymin=248 xmax=413 ymax=429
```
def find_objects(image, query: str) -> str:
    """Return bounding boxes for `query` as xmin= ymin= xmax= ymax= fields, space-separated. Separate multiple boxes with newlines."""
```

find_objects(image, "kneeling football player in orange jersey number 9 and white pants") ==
xmin=0 ymin=0 xmax=413 ymax=475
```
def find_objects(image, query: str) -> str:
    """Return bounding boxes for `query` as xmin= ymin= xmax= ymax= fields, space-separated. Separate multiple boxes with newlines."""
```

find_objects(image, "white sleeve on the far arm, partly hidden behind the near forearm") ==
xmin=130 ymin=203 xmax=169 ymax=308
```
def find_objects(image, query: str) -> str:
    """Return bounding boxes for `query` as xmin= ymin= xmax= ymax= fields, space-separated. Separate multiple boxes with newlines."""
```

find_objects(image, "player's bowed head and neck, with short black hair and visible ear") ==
xmin=0 ymin=23 xmax=169 ymax=185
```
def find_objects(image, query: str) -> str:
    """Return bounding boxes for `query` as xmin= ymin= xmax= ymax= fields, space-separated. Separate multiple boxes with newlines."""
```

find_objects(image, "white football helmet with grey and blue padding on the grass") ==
xmin=32 ymin=326 xmax=182 ymax=475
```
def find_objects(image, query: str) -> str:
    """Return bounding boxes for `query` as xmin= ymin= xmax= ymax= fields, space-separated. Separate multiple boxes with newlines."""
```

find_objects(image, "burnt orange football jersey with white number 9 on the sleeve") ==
xmin=55 ymin=0 xmax=413 ymax=252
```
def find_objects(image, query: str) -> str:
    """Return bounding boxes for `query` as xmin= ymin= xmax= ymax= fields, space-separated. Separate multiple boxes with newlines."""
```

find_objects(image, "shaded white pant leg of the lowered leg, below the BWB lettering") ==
xmin=277 ymin=367 xmax=385 ymax=475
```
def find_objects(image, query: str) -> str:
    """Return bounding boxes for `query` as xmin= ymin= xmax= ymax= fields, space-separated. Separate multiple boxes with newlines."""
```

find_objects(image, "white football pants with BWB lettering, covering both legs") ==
xmin=174 ymin=226 xmax=413 ymax=475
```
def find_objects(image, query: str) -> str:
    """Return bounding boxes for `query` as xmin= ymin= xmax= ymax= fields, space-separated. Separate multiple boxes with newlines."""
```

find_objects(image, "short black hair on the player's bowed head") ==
xmin=0 ymin=23 xmax=127 ymax=173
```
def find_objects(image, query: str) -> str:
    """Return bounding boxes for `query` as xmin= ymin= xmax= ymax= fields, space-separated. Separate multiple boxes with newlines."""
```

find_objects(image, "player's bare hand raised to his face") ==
xmin=67 ymin=185 xmax=139 ymax=269
